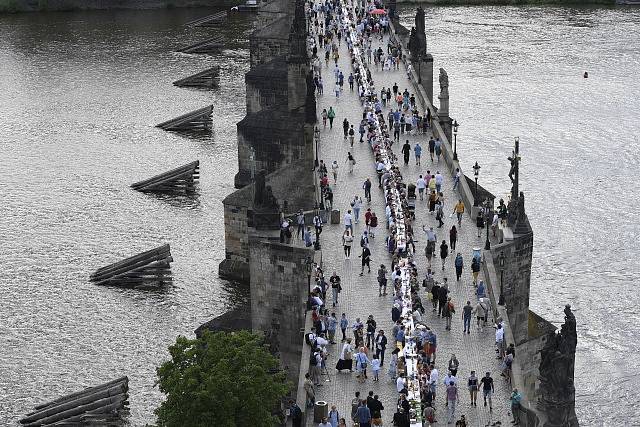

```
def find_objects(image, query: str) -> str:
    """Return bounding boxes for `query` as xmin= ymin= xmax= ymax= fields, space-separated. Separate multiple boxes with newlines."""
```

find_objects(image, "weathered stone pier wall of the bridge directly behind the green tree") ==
xmin=250 ymin=237 xmax=315 ymax=396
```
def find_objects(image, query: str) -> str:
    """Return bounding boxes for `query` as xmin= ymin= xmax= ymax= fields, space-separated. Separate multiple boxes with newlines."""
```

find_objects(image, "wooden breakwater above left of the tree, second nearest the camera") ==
xmin=89 ymin=244 xmax=173 ymax=288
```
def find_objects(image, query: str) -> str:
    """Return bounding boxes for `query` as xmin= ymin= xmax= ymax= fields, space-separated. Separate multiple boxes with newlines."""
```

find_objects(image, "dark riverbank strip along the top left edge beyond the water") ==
xmin=0 ymin=0 xmax=230 ymax=13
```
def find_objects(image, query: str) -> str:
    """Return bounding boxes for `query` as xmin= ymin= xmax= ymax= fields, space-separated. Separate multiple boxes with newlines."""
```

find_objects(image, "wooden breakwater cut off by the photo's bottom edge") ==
xmin=20 ymin=377 xmax=129 ymax=427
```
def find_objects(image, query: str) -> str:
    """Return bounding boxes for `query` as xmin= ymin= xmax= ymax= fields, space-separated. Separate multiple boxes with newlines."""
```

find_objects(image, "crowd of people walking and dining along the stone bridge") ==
xmin=292 ymin=0 xmax=521 ymax=427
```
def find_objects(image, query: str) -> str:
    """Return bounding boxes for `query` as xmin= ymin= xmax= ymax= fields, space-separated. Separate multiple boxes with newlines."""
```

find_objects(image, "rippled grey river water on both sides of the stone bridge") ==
xmin=0 ymin=7 xmax=640 ymax=425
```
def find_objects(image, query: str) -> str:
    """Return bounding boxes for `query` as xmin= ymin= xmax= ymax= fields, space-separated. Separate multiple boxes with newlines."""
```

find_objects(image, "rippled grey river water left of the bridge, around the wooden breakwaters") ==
xmin=0 ymin=9 xmax=250 ymax=425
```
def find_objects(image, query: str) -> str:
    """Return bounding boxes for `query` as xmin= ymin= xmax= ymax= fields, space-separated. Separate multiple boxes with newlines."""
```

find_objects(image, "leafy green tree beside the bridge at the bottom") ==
xmin=156 ymin=331 xmax=289 ymax=427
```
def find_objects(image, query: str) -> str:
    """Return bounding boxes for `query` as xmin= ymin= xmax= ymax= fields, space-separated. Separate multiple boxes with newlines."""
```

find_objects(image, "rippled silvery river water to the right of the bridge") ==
xmin=403 ymin=7 xmax=640 ymax=426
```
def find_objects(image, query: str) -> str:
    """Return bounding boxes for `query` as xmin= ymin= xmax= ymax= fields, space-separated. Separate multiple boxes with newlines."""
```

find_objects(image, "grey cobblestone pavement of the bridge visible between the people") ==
xmin=307 ymin=19 xmax=510 ymax=426
